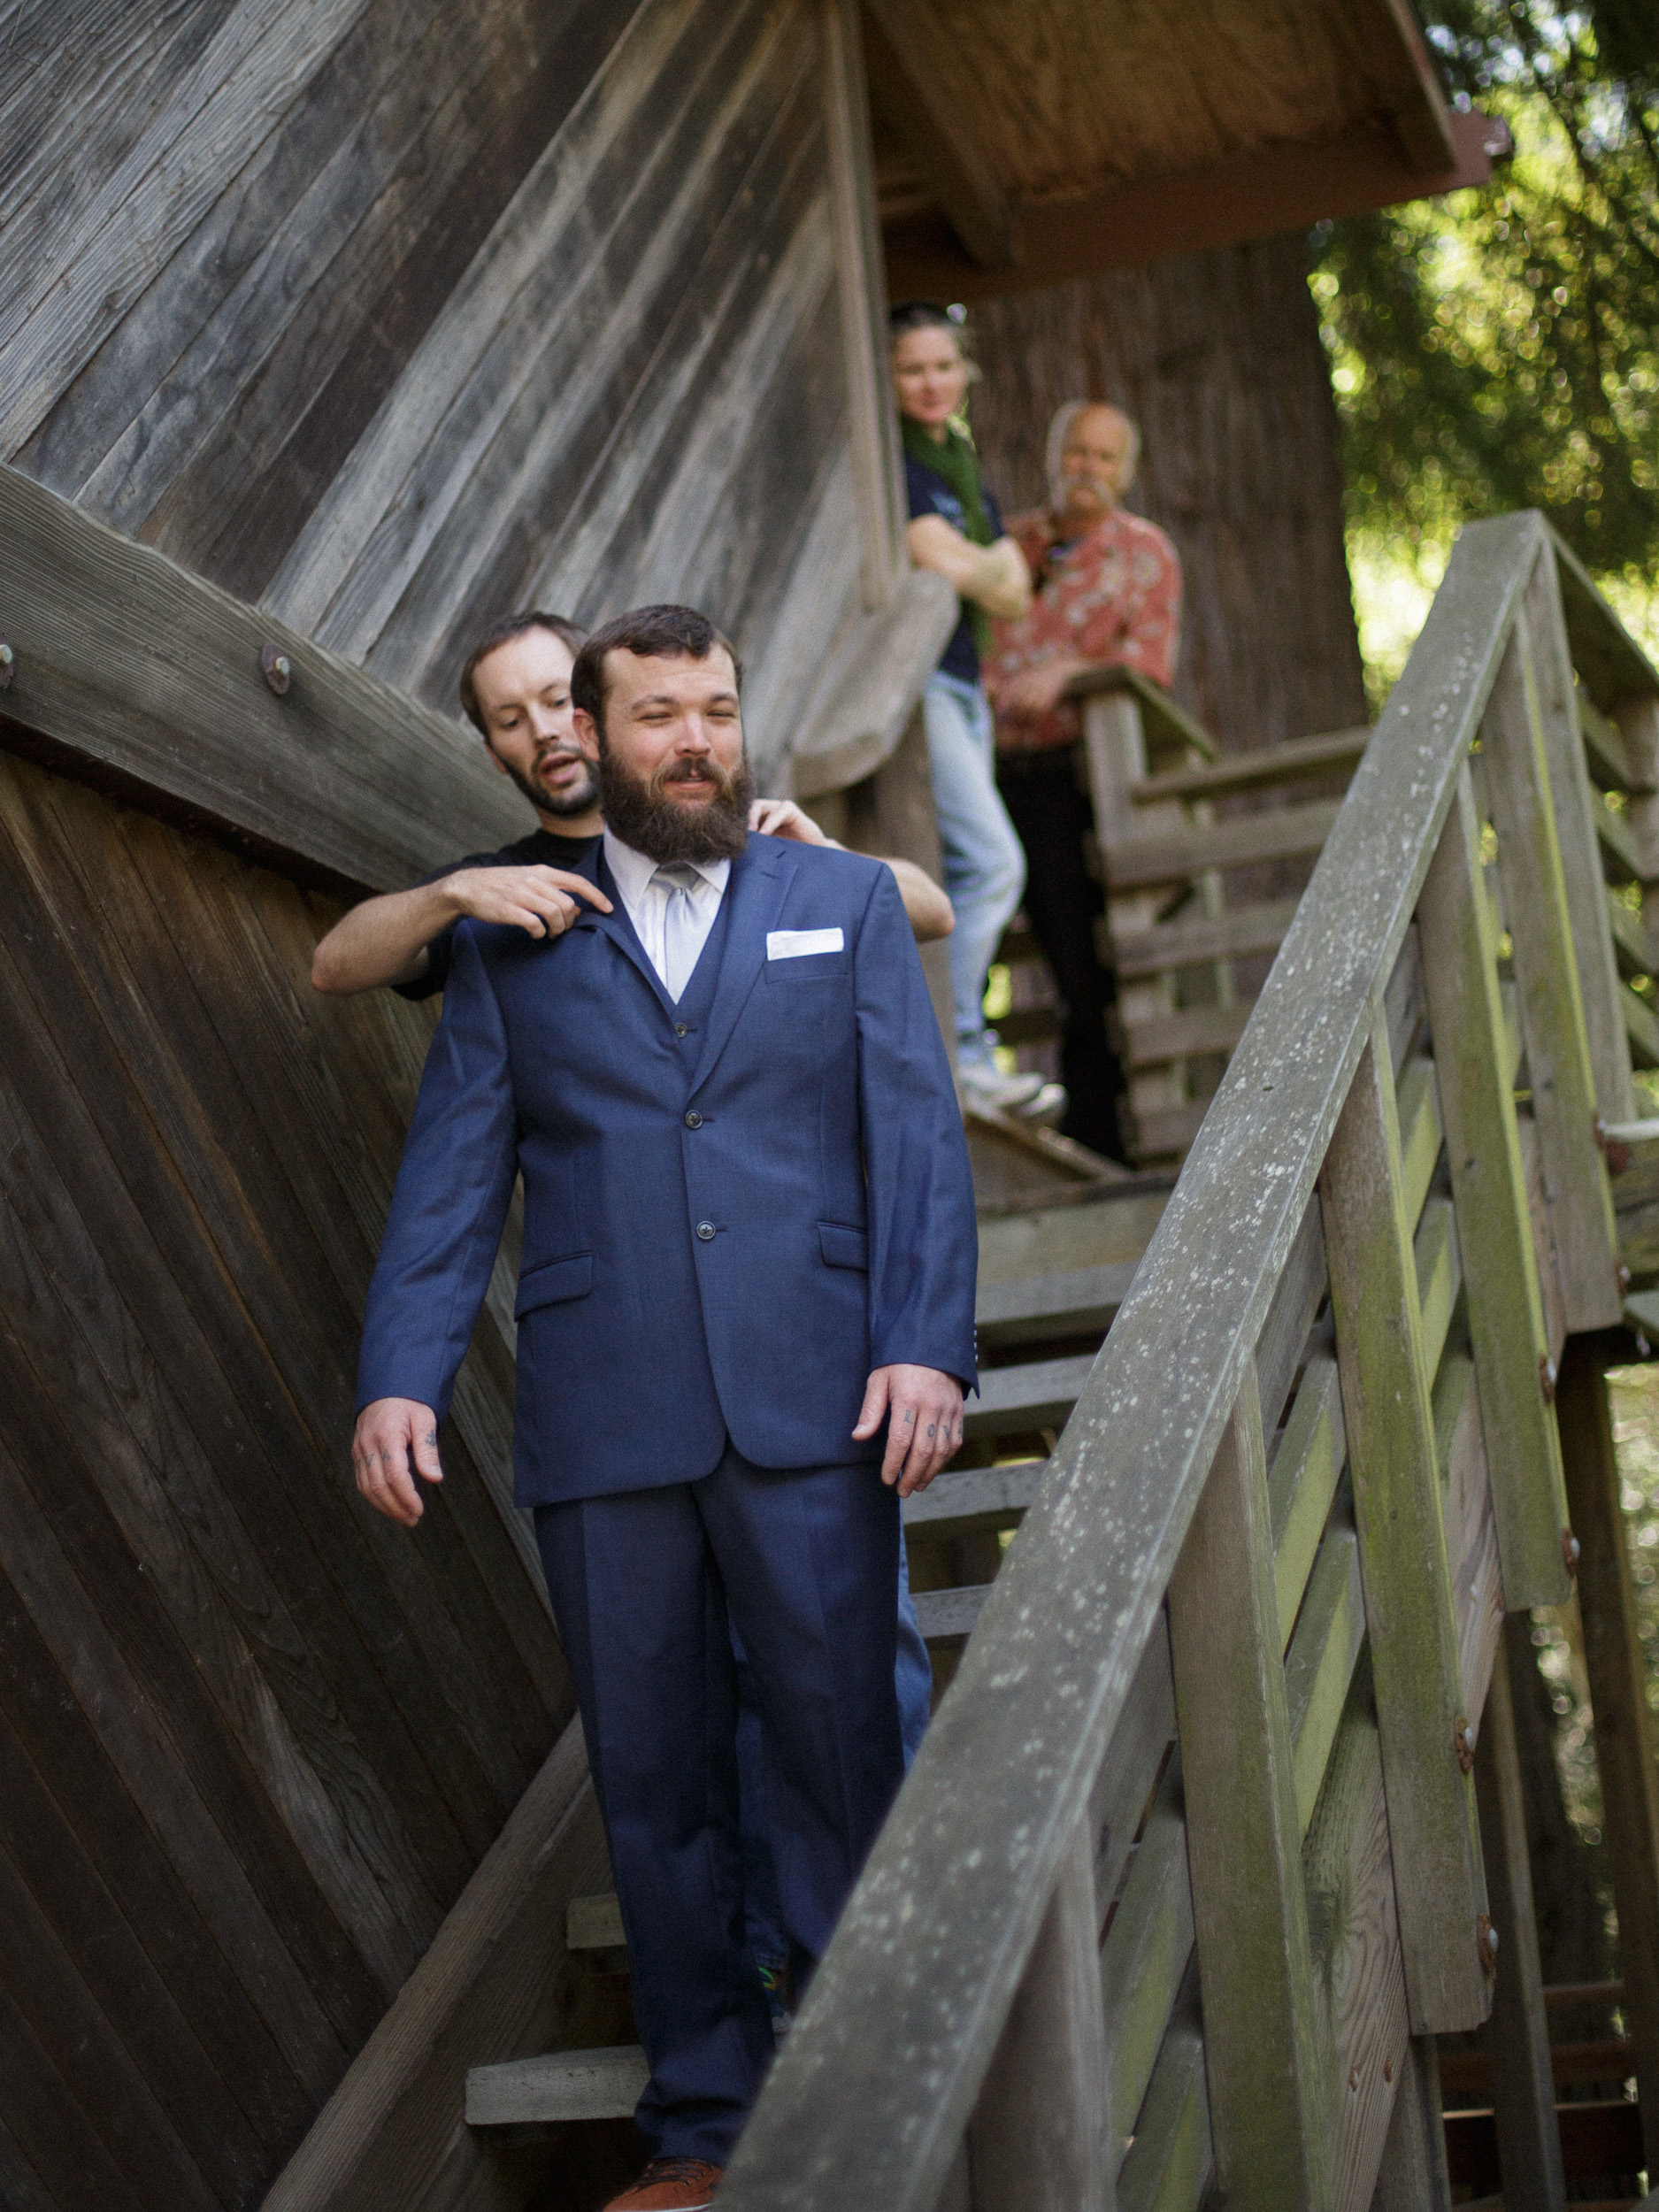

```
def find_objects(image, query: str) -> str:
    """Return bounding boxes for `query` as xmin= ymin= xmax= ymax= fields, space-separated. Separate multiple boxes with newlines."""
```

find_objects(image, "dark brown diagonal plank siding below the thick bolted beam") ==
xmin=0 ymin=764 xmax=573 ymax=2212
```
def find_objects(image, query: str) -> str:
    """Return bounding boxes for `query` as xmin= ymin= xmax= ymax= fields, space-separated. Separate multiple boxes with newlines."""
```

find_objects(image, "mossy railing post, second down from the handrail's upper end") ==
xmin=1418 ymin=768 xmax=1566 ymax=1609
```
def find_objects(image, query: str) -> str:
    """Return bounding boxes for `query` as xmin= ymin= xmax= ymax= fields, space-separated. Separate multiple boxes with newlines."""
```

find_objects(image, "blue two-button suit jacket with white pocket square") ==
xmin=358 ymin=836 xmax=978 ymax=1504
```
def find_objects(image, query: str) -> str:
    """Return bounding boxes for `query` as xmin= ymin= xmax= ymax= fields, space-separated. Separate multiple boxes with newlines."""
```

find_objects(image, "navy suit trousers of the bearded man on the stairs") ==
xmin=535 ymin=1445 xmax=902 ymax=2166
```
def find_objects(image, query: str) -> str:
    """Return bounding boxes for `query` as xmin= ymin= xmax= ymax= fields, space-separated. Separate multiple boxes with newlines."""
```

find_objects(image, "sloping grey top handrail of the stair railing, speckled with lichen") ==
xmin=721 ymin=513 xmax=1659 ymax=2212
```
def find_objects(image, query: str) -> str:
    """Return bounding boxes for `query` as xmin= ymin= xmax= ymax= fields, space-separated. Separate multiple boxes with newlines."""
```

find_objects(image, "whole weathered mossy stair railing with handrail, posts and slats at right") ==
xmin=721 ymin=516 xmax=1659 ymax=2212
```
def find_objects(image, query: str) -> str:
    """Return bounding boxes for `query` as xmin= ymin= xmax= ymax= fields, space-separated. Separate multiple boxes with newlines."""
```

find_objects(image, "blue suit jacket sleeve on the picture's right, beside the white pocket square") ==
xmin=854 ymin=870 xmax=978 ymax=1389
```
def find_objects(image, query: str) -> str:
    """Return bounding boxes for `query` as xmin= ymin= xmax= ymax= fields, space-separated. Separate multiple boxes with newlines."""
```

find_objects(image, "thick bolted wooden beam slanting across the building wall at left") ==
xmin=0 ymin=469 xmax=525 ymax=892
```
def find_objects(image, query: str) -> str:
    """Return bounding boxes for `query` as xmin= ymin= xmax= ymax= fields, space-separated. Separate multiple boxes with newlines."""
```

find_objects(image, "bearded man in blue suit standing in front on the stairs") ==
xmin=354 ymin=609 xmax=976 ymax=2212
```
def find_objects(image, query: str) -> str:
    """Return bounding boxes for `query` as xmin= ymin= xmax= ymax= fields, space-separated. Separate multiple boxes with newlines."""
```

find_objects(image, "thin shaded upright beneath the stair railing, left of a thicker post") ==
xmin=1476 ymin=1619 xmax=1566 ymax=2212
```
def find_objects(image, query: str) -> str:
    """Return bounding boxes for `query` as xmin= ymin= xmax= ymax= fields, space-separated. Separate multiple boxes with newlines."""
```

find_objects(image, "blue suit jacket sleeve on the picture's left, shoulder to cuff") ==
xmin=357 ymin=927 xmax=518 ymax=1420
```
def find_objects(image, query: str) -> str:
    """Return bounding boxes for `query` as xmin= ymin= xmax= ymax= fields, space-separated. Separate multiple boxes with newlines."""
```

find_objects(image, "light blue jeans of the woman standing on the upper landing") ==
xmin=923 ymin=671 xmax=1026 ymax=1060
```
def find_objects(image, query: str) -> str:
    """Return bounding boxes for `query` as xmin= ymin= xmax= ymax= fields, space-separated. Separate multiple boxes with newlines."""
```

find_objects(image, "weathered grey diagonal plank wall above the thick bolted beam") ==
xmin=0 ymin=0 xmax=898 ymax=781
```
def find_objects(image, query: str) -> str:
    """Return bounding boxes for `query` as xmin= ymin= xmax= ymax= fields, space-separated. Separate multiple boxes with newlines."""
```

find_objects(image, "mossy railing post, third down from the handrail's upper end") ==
xmin=1321 ymin=1013 xmax=1489 ymax=2033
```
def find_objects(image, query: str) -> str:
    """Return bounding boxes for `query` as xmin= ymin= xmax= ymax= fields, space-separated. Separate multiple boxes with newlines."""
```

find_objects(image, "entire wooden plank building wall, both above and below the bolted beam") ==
xmin=0 ymin=0 xmax=911 ymax=2212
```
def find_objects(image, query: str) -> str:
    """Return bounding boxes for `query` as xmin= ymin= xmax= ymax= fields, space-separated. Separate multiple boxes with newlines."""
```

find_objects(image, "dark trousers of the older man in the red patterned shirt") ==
xmin=998 ymin=746 xmax=1124 ymax=1159
